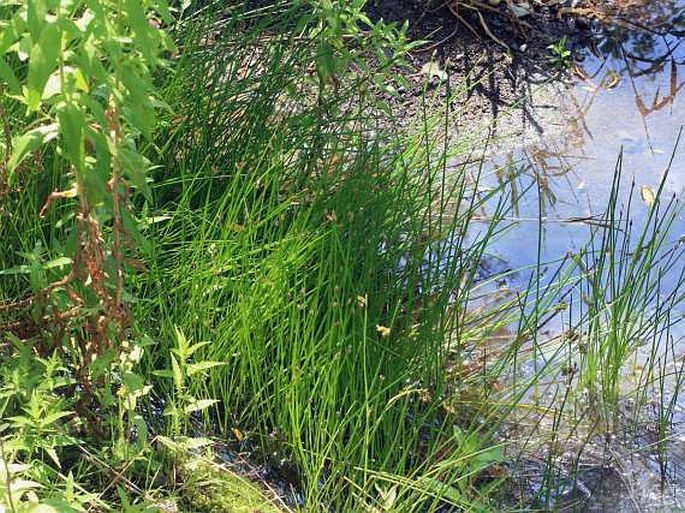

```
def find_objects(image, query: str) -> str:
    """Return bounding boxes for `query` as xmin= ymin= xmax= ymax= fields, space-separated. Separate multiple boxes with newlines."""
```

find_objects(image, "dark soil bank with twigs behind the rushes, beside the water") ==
xmin=366 ymin=0 xmax=590 ymax=144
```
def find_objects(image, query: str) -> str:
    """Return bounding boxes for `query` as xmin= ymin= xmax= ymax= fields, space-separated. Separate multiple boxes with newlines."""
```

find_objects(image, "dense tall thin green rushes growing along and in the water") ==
xmin=0 ymin=2 xmax=685 ymax=511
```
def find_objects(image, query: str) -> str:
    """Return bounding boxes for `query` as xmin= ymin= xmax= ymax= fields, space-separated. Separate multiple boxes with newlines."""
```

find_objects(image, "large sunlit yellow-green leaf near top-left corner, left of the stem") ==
xmin=26 ymin=23 xmax=61 ymax=112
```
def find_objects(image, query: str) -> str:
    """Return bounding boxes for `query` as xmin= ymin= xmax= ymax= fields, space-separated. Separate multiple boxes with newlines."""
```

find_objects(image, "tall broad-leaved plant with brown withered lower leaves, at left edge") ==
xmin=0 ymin=0 xmax=174 ymax=412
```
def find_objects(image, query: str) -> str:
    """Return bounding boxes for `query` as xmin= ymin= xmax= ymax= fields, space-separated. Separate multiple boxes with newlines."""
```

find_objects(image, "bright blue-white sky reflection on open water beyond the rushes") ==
xmin=494 ymin=0 xmax=685 ymax=276
